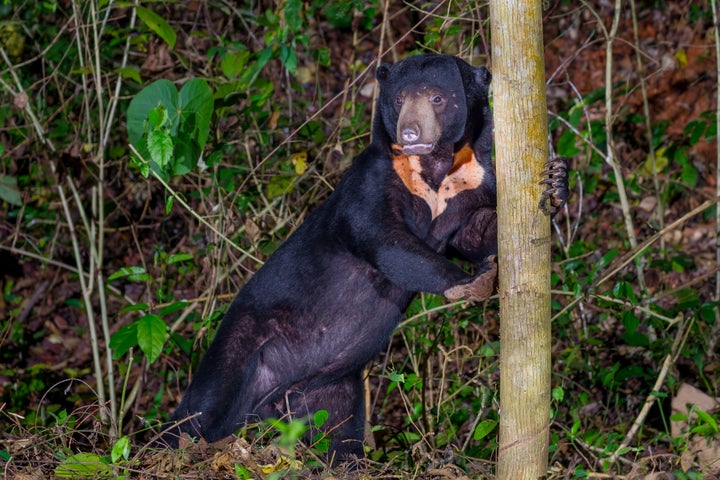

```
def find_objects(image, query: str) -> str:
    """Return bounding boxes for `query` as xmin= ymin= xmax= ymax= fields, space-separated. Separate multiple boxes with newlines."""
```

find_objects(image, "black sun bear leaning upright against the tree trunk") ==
xmin=161 ymin=55 xmax=567 ymax=460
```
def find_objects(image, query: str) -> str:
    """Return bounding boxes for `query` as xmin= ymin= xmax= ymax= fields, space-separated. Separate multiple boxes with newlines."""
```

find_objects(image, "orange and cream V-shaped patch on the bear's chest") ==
xmin=392 ymin=145 xmax=485 ymax=219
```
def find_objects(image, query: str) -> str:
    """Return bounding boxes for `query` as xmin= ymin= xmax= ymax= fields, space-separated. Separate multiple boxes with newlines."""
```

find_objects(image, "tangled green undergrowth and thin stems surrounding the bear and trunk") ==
xmin=0 ymin=0 xmax=720 ymax=479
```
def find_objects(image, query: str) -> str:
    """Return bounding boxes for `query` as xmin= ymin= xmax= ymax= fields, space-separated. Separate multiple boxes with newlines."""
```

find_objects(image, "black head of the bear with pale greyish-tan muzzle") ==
xmin=373 ymin=55 xmax=491 ymax=155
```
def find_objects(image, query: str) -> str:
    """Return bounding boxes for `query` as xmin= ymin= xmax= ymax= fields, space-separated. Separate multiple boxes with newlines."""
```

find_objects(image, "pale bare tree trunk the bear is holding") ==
xmin=490 ymin=0 xmax=551 ymax=480
